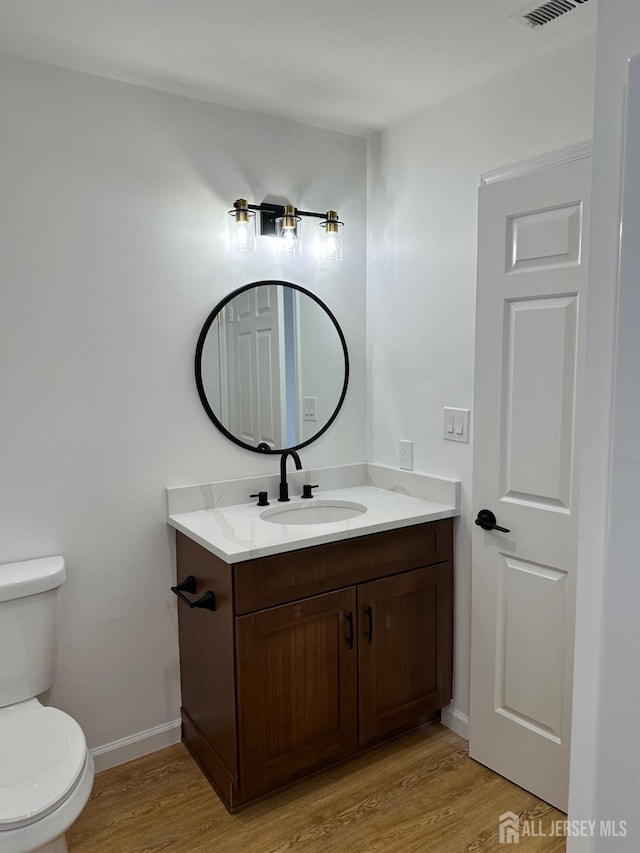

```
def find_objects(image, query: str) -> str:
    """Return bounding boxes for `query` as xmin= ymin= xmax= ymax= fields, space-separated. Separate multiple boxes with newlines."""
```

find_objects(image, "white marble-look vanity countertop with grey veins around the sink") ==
xmin=167 ymin=481 xmax=460 ymax=563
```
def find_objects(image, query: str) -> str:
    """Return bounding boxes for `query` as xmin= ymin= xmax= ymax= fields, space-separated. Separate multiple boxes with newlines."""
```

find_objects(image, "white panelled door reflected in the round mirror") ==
xmin=226 ymin=284 xmax=284 ymax=448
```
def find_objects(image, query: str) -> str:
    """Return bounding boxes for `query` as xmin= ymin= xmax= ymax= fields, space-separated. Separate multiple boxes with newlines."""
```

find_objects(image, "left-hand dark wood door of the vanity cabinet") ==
xmin=236 ymin=587 xmax=357 ymax=798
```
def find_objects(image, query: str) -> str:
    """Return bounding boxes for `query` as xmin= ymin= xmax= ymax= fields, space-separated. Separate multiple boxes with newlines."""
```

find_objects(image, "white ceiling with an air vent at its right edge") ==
xmin=0 ymin=0 xmax=596 ymax=134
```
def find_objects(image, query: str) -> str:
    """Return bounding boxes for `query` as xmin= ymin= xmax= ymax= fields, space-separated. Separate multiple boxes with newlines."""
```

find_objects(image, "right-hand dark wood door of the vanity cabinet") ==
xmin=358 ymin=563 xmax=452 ymax=743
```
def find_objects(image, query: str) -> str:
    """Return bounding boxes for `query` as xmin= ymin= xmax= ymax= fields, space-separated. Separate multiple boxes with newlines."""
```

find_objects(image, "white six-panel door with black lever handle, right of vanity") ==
xmin=469 ymin=151 xmax=591 ymax=811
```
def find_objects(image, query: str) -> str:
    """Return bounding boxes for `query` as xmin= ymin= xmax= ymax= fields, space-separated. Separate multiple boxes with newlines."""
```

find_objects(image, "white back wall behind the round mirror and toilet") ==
xmin=0 ymin=57 xmax=366 ymax=747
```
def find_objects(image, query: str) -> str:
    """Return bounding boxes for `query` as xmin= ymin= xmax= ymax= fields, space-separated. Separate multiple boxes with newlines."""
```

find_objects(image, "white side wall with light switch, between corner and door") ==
xmin=367 ymin=36 xmax=594 ymax=720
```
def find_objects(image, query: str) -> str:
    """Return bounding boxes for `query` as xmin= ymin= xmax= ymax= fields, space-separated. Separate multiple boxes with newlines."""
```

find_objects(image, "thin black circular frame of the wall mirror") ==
xmin=195 ymin=279 xmax=349 ymax=455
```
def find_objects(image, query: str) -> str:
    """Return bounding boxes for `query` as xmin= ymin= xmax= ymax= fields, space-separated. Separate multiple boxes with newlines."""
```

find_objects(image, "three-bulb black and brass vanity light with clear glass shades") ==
xmin=229 ymin=198 xmax=344 ymax=261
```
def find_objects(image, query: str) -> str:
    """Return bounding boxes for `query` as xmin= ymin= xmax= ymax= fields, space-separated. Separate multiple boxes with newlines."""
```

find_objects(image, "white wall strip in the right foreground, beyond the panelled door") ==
xmin=567 ymin=0 xmax=640 ymax=853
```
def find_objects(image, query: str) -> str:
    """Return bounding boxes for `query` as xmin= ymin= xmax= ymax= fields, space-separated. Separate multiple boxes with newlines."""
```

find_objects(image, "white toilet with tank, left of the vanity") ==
xmin=0 ymin=557 xmax=94 ymax=853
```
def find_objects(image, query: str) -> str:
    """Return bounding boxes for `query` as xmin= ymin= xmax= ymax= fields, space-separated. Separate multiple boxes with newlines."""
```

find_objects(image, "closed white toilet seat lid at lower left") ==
xmin=0 ymin=699 xmax=87 ymax=832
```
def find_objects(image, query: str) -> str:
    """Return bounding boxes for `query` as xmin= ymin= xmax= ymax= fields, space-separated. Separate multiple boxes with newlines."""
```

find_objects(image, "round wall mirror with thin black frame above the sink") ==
xmin=196 ymin=281 xmax=349 ymax=453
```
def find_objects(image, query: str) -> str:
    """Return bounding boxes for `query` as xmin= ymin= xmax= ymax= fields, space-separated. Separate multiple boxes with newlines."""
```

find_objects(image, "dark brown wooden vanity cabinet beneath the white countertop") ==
xmin=176 ymin=518 xmax=453 ymax=812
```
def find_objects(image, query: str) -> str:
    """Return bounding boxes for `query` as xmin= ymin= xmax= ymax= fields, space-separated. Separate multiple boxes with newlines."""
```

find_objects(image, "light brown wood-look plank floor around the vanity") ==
xmin=67 ymin=723 xmax=565 ymax=853
